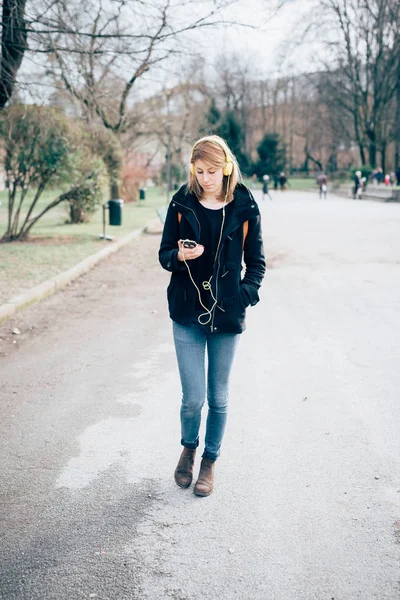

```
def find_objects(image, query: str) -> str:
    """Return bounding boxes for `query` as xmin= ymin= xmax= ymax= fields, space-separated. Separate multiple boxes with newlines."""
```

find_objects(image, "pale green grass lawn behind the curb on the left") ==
xmin=0 ymin=188 xmax=166 ymax=304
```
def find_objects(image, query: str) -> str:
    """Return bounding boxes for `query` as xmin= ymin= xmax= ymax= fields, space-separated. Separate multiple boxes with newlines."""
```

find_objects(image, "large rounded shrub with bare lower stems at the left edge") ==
xmin=0 ymin=105 xmax=106 ymax=242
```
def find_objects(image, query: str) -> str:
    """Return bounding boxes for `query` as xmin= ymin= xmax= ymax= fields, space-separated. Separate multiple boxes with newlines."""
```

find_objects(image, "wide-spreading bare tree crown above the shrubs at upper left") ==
xmin=23 ymin=0 xmax=238 ymax=195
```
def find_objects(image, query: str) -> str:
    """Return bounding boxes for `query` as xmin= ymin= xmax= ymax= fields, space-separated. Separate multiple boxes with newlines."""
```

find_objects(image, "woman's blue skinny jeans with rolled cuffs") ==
xmin=172 ymin=321 xmax=240 ymax=460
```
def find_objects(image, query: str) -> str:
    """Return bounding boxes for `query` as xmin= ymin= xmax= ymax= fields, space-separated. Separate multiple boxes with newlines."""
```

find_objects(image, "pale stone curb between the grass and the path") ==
xmin=0 ymin=226 xmax=149 ymax=323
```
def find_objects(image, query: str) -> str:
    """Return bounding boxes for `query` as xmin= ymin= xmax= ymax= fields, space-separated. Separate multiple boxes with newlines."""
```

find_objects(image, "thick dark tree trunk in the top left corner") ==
xmin=0 ymin=0 xmax=27 ymax=109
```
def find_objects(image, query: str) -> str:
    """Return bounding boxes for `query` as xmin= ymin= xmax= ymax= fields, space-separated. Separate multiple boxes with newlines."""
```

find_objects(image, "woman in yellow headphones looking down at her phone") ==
xmin=159 ymin=135 xmax=265 ymax=496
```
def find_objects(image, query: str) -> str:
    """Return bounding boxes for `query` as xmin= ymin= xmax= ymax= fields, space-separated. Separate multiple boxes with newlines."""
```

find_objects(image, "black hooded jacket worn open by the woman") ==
xmin=159 ymin=184 xmax=265 ymax=333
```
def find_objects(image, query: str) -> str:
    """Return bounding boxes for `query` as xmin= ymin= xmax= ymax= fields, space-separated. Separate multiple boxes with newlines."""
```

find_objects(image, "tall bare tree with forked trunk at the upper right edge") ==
xmin=322 ymin=0 xmax=400 ymax=167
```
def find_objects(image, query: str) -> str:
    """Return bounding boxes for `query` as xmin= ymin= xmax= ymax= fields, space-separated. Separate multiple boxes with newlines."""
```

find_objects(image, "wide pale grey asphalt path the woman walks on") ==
xmin=0 ymin=192 xmax=400 ymax=600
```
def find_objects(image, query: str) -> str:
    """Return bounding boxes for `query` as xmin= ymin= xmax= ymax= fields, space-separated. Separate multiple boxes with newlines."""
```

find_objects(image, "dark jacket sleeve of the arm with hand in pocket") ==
xmin=241 ymin=215 xmax=266 ymax=306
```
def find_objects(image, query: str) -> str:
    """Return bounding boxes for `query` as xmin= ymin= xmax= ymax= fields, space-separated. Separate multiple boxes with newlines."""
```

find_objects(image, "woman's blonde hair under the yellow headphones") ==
xmin=187 ymin=135 xmax=243 ymax=202
